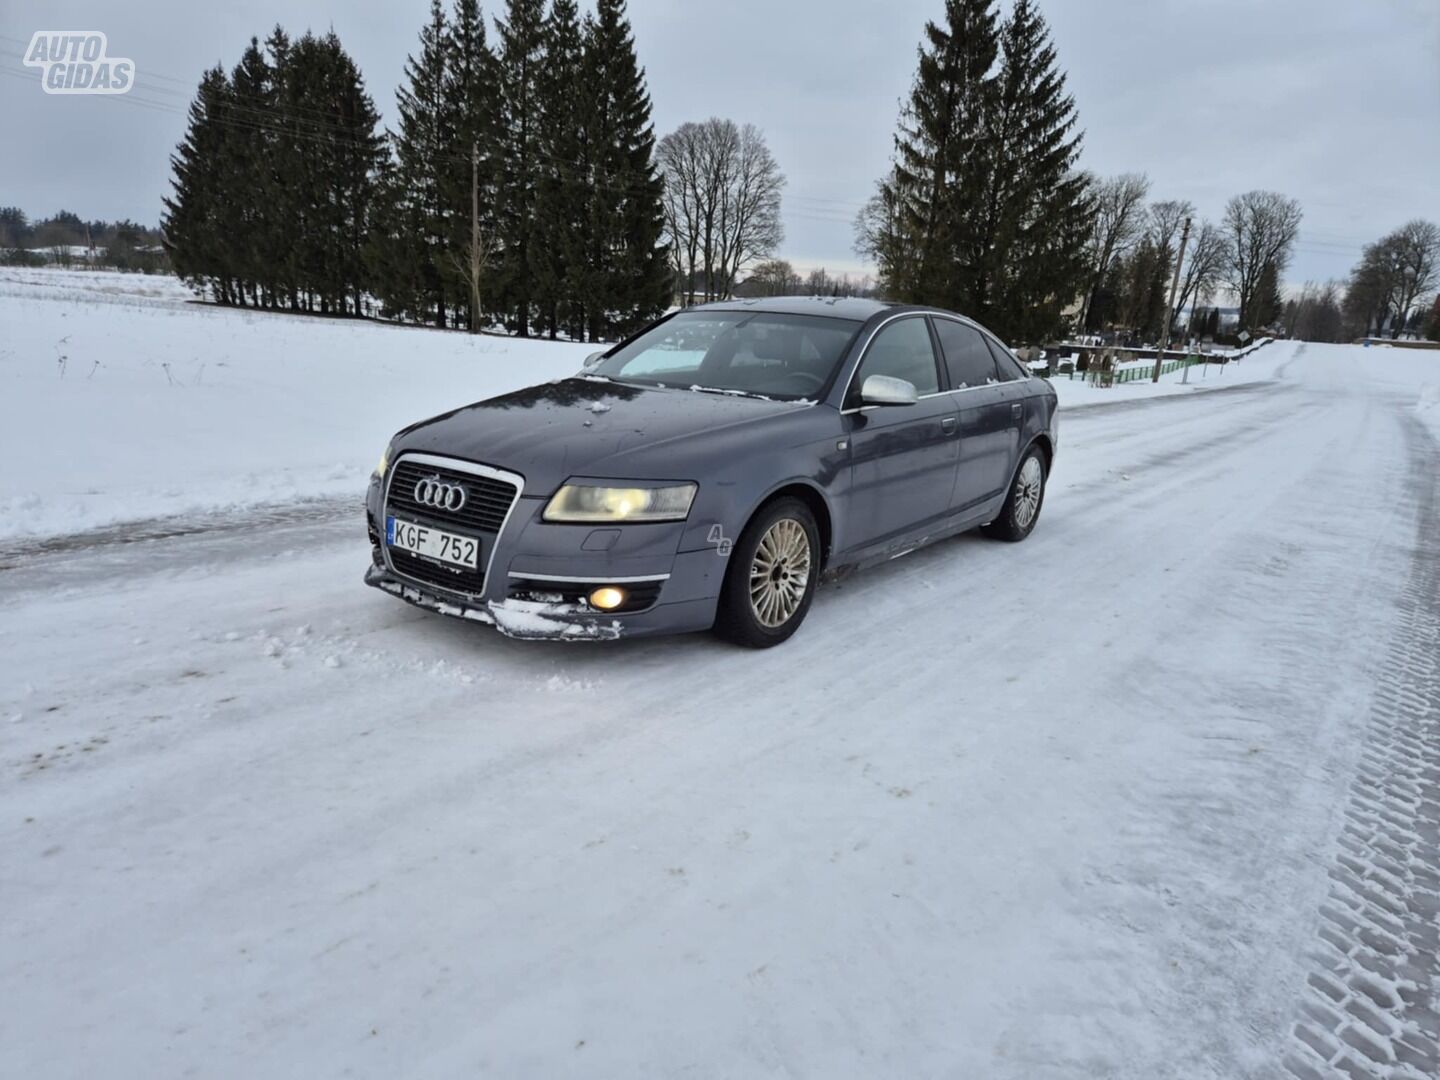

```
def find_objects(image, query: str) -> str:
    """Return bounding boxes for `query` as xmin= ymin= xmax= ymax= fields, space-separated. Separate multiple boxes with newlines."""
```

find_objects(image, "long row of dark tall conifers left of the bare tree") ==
xmin=163 ymin=0 xmax=671 ymax=340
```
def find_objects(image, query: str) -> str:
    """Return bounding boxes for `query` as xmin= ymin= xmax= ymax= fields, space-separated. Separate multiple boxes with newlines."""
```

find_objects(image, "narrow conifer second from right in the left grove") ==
xmin=528 ymin=0 xmax=584 ymax=338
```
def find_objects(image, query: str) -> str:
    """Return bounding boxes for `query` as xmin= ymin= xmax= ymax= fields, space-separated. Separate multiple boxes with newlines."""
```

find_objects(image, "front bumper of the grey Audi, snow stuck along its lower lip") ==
xmin=364 ymin=472 xmax=729 ymax=641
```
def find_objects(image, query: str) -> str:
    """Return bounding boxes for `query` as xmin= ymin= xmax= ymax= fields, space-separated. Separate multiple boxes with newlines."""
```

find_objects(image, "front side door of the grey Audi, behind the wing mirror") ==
xmin=844 ymin=314 xmax=960 ymax=549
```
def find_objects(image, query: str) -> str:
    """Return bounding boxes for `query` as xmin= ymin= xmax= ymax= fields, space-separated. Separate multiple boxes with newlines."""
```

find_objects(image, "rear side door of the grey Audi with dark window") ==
xmin=935 ymin=315 xmax=1024 ymax=511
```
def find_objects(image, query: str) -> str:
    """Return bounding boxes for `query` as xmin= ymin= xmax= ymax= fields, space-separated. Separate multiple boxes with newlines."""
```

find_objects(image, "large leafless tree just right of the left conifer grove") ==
xmin=658 ymin=117 xmax=785 ymax=304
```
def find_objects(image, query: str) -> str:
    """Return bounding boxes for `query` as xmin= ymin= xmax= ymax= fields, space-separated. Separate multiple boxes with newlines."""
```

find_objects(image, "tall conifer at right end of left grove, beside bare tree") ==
xmin=586 ymin=0 xmax=671 ymax=341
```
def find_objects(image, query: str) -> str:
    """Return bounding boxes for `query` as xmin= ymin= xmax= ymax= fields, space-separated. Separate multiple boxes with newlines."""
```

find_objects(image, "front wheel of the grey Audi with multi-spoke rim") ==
xmin=714 ymin=497 xmax=819 ymax=649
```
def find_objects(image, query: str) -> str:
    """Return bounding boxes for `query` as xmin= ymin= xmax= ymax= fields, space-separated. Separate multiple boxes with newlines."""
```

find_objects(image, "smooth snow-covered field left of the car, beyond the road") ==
xmin=0 ymin=269 xmax=593 ymax=536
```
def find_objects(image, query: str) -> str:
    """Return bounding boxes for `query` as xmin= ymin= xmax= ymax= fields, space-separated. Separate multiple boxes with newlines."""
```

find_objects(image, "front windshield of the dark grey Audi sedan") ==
xmin=590 ymin=311 xmax=860 ymax=400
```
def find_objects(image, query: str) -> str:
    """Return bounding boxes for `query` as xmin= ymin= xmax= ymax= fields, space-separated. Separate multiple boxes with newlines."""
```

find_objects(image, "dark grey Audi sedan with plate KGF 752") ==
xmin=364 ymin=298 xmax=1058 ymax=648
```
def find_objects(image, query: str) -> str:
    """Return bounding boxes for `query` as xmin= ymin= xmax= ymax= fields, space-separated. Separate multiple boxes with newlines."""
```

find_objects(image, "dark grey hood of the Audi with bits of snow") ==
xmin=395 ymin=377 xmax=809 ymax=495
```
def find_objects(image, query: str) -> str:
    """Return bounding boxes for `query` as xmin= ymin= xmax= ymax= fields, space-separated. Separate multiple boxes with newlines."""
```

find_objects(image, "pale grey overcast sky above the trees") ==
xmin=0 ymin=0 xmax=1440 ymax=282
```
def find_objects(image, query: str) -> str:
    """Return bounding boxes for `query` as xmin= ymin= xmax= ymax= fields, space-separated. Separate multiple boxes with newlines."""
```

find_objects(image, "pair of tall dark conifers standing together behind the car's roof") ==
xmin=874 ymin=0 xmax=1096 ymax=340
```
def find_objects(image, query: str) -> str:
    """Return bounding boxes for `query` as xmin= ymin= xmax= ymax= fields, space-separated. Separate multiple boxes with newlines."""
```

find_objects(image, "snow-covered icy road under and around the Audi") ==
xmin=0 ymin=346 xmax=1440 ymax=1080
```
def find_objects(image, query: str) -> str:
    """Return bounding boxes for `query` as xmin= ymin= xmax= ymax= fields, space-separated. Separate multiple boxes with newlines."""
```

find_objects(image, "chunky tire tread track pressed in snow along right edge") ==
xmin=1284 ymin=422 xmax=1440 ymax=1080
